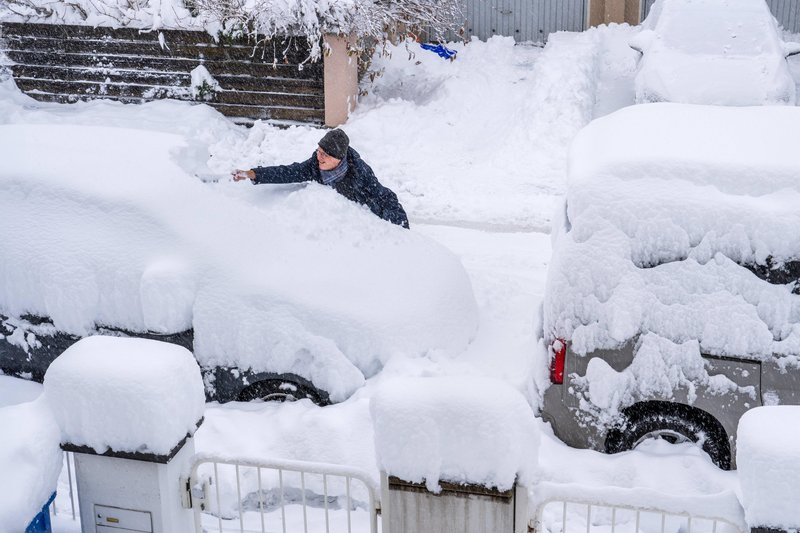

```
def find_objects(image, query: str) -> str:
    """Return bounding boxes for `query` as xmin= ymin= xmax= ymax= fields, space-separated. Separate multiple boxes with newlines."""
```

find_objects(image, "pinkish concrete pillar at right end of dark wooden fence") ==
xmin=323 ymin=35 xmax=358 ymax=128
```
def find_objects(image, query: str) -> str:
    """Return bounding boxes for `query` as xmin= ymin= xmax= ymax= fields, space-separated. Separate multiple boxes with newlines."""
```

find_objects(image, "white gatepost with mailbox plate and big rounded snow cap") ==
xmin=44 ymin=335 xmax=205 ymax=533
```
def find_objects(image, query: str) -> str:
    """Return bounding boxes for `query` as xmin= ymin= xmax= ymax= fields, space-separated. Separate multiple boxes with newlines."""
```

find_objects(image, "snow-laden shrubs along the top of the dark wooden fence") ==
xmin=0 ymin=0 xmax=463 ymax=60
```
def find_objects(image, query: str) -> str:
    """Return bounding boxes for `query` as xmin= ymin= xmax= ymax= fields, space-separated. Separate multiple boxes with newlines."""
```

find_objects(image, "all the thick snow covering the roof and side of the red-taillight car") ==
xmin=544 ymin=104 xmax=800 ymax=406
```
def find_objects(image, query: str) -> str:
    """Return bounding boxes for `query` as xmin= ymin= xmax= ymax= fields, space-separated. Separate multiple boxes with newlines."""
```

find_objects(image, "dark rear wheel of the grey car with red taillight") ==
xmin=605 ymin=402 xmax=731 ymax=470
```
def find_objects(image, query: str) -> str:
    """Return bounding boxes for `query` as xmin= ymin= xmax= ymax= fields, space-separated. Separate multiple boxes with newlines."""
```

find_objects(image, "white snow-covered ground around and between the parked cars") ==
xmin=0 ymin=20 xmax=800 ymax=532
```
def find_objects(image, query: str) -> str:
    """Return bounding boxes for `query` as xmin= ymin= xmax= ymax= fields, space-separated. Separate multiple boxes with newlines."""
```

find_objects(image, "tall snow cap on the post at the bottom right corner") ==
xmin=736 ymin=405 xmax=800 ymax=530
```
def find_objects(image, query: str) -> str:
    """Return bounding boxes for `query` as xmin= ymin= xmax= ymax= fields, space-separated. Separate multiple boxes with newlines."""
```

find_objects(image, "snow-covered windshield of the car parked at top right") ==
xmin=657 ymin=4 xmax=774 ymax=56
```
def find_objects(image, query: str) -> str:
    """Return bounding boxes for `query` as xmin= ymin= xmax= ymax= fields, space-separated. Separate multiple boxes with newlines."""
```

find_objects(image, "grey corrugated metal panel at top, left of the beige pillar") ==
xmin=464 ymin=0 xmax=587 ymax=42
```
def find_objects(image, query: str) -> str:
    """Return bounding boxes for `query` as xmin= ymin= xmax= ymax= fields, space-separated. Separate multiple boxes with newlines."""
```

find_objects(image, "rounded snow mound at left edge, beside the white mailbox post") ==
xmin=0 ymin=399 xmax=62 ymax=532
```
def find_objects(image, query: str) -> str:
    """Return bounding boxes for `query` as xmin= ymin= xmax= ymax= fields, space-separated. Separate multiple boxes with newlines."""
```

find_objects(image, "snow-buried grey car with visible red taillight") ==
xmin=542 ymin=103 xmax=800 ymax=468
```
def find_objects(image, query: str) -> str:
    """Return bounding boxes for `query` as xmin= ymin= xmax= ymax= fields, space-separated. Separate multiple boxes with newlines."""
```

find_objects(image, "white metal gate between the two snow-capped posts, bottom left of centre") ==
xmin=188 ymin=457 xmax=380 ymax=533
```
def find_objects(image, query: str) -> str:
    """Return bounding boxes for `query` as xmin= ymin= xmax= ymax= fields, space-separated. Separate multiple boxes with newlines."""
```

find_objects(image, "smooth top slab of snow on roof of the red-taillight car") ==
xmin=568 ymin=103 xmax=800 ymax=196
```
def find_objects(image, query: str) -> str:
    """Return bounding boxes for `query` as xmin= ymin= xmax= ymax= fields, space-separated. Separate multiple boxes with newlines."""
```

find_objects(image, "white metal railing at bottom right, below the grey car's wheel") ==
xmin=533 ymin=499 xmax=745 ymax=533
